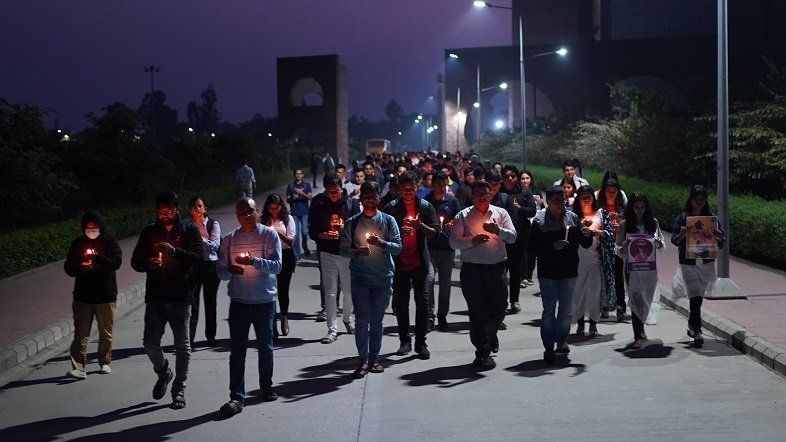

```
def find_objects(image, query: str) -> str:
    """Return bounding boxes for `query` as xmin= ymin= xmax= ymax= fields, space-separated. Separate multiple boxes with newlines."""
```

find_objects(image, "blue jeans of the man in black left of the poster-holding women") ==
xmin=538 ymin=278 xmax=576 ymax=350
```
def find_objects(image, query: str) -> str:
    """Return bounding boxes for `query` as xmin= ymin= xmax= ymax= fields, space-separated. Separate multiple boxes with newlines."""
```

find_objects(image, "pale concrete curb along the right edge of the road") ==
xmin=659 ymin=284 xmax=786 ymax=377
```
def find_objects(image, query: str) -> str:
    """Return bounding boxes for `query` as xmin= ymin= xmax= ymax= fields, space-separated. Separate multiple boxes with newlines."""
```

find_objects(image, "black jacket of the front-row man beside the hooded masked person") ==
xmin=131 ymin=217 xmax=202 ymax=303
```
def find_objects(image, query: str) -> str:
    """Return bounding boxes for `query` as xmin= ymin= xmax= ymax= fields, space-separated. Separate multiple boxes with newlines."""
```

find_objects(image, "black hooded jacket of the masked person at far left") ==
xmin=63 ymin=210 xmax=123 ymax=304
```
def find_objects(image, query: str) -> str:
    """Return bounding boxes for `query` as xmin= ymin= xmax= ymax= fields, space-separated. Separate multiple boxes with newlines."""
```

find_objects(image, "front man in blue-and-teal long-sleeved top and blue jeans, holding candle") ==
xmin=339 ymin=181 xmax=401 ymax=379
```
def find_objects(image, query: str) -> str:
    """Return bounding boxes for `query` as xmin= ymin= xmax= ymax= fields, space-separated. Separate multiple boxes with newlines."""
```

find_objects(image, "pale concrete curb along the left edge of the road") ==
xmin=0 ymin=282 xmax=145 ymax=375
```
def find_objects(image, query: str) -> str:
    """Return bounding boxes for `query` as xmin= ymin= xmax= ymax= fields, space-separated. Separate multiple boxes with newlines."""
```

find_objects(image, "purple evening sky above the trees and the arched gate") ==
xmin=0 ymin=0 xmax=511 ymax=129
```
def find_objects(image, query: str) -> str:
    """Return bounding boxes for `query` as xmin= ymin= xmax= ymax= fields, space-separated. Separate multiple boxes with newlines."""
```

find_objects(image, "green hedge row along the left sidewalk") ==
xmin=0 ymin=171 xmax=291 ymax=278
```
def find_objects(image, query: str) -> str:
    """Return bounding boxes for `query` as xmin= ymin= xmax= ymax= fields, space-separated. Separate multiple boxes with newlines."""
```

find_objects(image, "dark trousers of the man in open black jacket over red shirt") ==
xmin=393 ymin=263 xmax=428 ymax=345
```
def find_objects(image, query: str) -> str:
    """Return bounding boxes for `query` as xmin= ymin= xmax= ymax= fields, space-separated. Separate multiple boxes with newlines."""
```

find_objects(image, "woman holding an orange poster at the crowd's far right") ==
xmin=671 ymin=185 xmax=726 ymax=348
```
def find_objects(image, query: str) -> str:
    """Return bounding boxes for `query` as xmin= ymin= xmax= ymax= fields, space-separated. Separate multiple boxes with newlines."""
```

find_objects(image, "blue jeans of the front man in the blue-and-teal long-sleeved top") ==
xmin=351 ymin=277 xmax=392 ymax=364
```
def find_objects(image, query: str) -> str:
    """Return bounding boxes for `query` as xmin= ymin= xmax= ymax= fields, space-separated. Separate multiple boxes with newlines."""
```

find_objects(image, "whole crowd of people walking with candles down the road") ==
xmin=59 ymin=153 xmax=725 ymax=415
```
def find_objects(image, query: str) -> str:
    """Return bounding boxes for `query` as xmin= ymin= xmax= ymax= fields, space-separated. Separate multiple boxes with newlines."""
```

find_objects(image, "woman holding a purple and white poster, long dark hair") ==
xmin=615 ymin=192 xmax=665 ymax=349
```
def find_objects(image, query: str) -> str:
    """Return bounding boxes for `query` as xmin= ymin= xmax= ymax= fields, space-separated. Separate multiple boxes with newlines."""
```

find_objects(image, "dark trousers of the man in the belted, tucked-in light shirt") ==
xmin=459 ymin=262 xmax=507 ymax=357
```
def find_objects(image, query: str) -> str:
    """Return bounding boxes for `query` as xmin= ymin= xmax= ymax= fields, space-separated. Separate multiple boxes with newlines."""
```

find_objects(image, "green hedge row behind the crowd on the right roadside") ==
xmin=530 ymin=165 xmax=786 ymax=269
